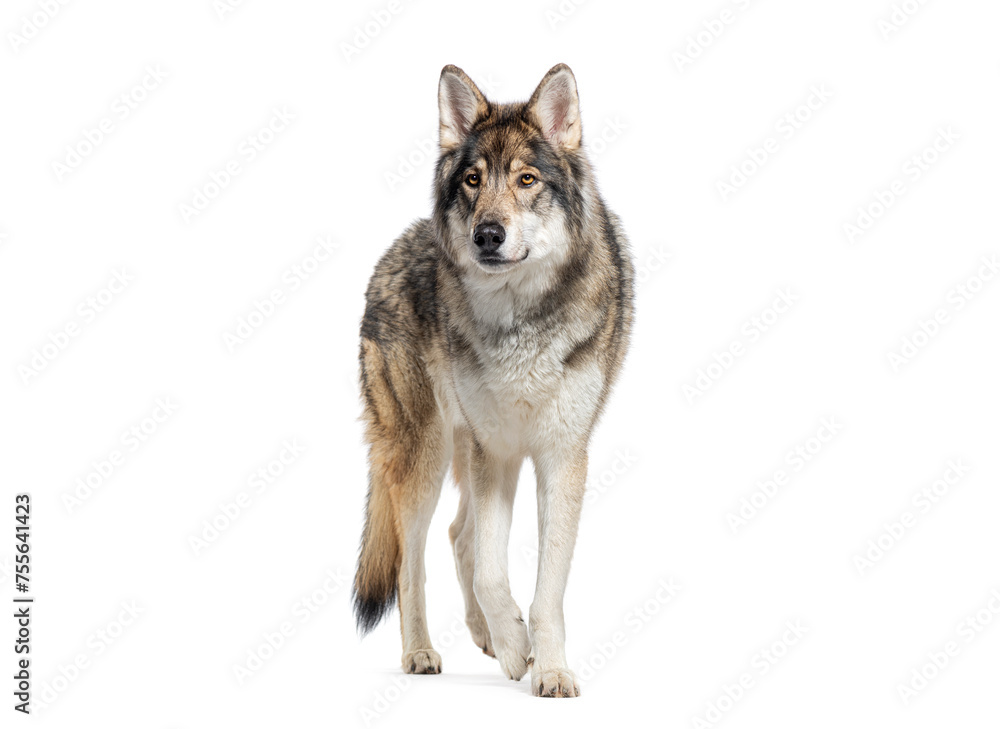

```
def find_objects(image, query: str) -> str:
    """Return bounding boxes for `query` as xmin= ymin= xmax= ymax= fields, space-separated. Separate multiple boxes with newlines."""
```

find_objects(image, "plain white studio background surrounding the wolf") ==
xmin=0 ymin=0 xmax=1000 ymax=727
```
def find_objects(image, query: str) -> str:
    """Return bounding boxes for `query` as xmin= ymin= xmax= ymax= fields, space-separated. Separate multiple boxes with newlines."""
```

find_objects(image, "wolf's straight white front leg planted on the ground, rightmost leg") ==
xmin=528 ymin=446 xmax=587 ymax=697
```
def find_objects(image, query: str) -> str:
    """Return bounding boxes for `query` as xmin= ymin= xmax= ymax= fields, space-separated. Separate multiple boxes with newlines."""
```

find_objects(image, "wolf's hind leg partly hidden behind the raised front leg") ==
xmin=448 ymin=428 xmax=496 ymax=658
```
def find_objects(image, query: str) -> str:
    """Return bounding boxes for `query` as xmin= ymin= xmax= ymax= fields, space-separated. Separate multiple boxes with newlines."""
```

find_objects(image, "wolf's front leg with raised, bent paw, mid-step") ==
xmin=472 ymin=442 xmax=531 ymax=681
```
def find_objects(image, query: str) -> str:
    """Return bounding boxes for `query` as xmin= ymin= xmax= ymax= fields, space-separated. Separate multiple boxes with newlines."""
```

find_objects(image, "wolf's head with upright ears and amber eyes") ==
xmin=434 ymin=64 xmax=593 ymax=285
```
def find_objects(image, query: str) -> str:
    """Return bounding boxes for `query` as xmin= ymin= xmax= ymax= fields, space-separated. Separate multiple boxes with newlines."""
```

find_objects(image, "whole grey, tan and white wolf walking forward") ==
xmin=354 ymin=64 xmax=633 ymax=697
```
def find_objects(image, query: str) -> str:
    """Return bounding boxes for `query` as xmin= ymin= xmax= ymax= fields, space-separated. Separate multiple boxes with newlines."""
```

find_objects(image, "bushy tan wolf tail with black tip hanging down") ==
xmin=353 ymin=477 xmax=400 ymax=635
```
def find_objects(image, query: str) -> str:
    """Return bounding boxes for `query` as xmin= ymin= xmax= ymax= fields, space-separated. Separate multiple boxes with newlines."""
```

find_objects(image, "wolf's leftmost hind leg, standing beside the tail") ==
xmin=393 ymin=422 xmax=448 ymax=673
